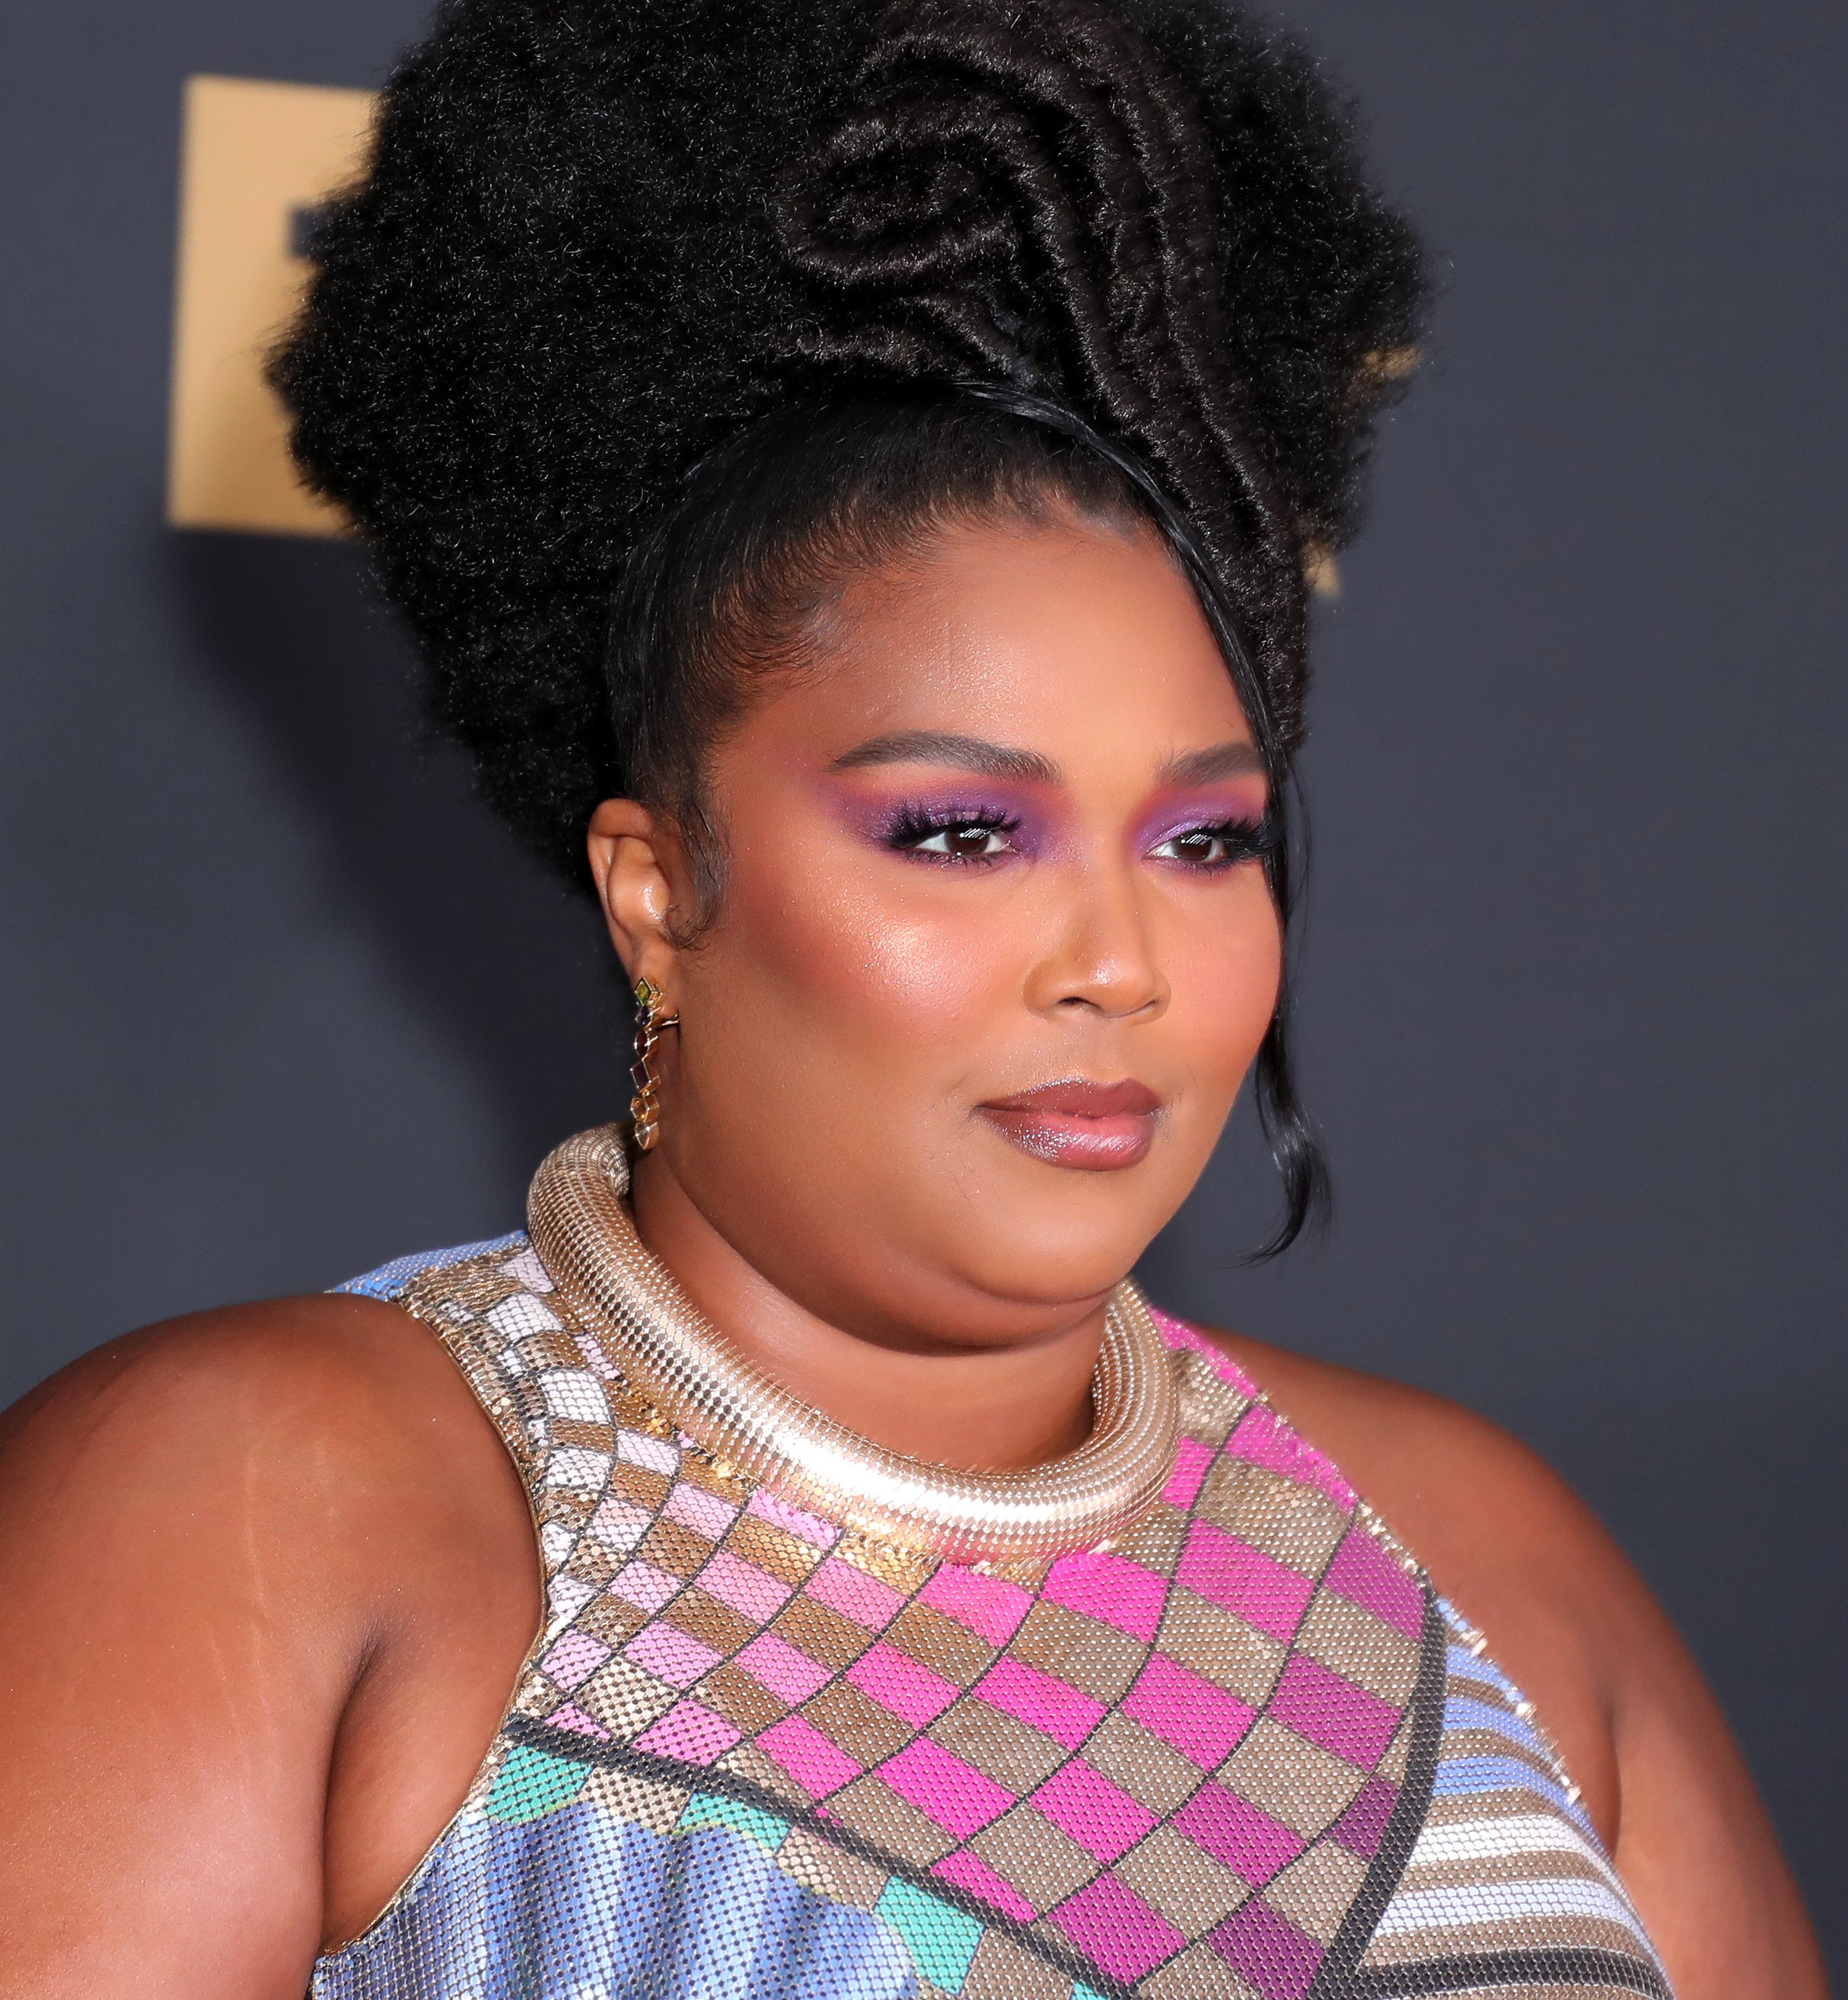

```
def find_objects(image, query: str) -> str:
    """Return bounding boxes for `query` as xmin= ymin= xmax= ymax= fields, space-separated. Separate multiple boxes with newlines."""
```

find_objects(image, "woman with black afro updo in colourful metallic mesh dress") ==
xmin=0 ymin=0 xmax=1822 ymax=2000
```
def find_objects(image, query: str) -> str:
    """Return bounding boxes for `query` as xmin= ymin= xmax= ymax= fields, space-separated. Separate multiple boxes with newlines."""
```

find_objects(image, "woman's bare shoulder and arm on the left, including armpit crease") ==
xmin=0 ymin=1296 xmax=536 ymax=2000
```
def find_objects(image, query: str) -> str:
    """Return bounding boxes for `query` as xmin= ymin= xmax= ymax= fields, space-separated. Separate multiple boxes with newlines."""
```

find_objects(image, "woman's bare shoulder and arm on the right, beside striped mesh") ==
xmin=1202 ymin=1328 xmax=1826 ymax=2000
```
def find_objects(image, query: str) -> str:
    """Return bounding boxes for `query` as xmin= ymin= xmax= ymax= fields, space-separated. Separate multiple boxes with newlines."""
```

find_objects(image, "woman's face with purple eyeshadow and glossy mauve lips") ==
xmin=600 ymin=516 xmax=1280 ymax=1348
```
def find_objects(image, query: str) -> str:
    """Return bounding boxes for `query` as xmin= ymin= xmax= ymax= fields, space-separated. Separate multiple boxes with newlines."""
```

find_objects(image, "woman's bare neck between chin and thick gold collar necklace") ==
xmin=632 ymin=1152 xmax=1106 ymax=1472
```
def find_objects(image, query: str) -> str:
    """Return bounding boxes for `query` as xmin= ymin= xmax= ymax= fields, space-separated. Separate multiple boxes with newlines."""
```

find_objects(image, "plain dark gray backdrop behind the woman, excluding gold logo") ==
xmin=0 ymin=0 xmax=1848 ymax=1962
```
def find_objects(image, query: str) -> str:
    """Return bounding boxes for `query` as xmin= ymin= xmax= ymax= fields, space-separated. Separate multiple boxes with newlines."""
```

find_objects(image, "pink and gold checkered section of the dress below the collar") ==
xmin=412 ymin=1250 xmax=1426 ymax=2000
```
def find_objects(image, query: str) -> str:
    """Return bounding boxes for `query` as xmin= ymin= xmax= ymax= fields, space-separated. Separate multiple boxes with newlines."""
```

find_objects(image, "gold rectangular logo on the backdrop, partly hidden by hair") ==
xmin=166 ymin=76 xmax=374 ymax=534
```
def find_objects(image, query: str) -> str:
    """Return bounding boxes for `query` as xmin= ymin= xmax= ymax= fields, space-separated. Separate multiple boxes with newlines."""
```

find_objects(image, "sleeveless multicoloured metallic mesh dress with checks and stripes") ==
xmin=312 ymin=1236 xmax=1668 ymax=2000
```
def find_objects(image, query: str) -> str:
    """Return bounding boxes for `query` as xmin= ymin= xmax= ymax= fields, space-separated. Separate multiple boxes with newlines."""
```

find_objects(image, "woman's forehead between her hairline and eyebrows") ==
xmin=736 ymin=516 xmax=1250 ymax=774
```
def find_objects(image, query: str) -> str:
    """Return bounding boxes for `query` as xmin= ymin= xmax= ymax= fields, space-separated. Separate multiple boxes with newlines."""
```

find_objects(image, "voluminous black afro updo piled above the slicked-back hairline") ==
xmin=272 ymin=0 xmax=1424 ymax=870
